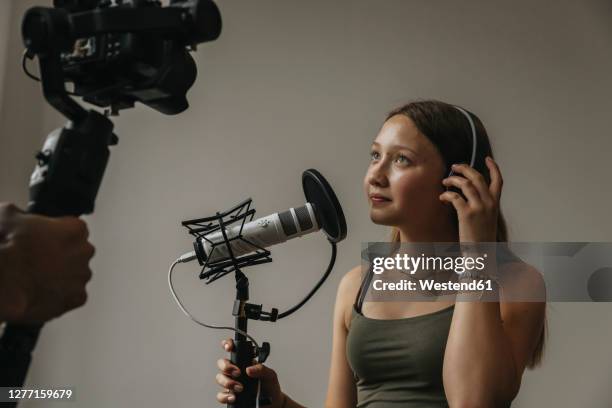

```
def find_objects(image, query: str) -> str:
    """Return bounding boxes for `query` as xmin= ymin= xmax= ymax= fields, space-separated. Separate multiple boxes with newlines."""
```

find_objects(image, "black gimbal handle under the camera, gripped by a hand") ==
xmin=0 ymin=111 xmax=116 ymax=398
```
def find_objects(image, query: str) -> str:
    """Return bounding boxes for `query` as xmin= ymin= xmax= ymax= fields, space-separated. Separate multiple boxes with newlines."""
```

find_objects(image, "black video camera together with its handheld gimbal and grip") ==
xmin=0 ymin=0 xmax=221 ymax=396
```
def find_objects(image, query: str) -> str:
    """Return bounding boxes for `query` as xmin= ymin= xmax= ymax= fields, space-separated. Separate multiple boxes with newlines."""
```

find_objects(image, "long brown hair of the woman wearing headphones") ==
xmin=385 ymin=100 xmax=548 ymax=368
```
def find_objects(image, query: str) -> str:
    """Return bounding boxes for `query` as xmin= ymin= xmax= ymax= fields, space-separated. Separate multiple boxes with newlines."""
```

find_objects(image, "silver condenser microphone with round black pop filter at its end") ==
xmin=179 ymin=169 xmax=346 ymax=265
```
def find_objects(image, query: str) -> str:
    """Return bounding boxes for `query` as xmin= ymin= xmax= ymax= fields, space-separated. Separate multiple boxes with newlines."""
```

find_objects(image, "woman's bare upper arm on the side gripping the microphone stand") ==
xmin=325 ymin=266 xmax=361 ymax=408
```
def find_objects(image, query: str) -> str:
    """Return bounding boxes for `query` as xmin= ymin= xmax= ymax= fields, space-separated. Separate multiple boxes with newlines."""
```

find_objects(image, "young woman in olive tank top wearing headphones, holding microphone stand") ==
xmin=216 ymin=101 xmax=545 ymax=408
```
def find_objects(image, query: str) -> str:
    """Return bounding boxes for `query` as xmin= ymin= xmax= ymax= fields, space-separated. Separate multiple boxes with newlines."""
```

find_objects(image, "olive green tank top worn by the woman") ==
xmin=346 ymin=244 xmax=520 ymax=408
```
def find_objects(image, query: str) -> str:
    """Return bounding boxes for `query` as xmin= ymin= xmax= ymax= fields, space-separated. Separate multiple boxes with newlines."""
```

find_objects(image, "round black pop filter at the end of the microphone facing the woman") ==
xmin=302 ymin=169 xmax=346 ymax=243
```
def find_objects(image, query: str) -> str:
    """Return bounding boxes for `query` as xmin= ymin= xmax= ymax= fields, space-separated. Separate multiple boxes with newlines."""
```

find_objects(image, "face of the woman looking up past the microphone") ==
xmin=364 ymin=115 xmax=448 ymax=228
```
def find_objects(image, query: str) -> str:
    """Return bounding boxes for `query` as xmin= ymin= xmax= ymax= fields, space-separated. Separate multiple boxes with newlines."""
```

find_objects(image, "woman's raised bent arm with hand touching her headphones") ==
xmin=440 ymin=156 xmax=546 ymax=408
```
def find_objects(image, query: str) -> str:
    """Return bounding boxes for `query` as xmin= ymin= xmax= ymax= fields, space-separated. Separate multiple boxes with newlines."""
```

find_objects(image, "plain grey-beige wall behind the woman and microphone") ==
xmin=0 ymin=0 xmax=612 ymax=408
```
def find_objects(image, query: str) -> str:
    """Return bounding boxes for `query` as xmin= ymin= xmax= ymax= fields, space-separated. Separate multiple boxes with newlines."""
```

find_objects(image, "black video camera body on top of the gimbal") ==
xmin=22 ymin=0 xmax=221 ymax=119
